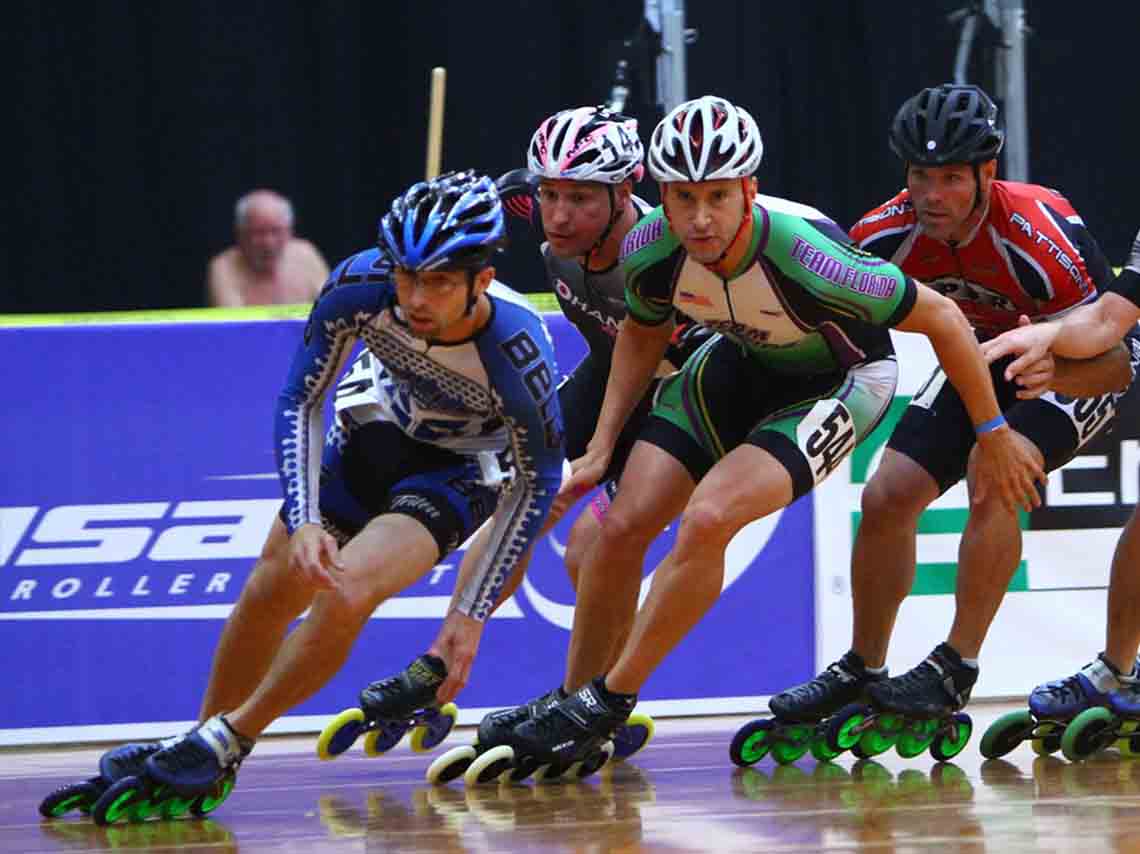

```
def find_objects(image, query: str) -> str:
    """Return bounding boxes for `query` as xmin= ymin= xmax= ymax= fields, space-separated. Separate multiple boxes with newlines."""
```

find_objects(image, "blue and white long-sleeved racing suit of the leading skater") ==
xmin=275 ymin=250 xmax=564 ymax=620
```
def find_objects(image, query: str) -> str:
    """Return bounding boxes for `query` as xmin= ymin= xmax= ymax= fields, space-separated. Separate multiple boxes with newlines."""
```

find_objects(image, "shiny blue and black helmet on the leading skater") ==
xmin=380 ymin=170 xmax=506 ymax=273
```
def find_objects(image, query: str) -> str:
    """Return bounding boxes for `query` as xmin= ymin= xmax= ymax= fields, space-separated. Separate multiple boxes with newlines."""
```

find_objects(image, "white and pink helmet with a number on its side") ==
xmin=527 ymin=107 xmax=645 ymax=184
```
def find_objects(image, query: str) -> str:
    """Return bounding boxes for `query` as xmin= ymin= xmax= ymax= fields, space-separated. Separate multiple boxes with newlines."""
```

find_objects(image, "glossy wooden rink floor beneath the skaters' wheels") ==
xmin=8 ymin=706 xmax=1140 ymax=854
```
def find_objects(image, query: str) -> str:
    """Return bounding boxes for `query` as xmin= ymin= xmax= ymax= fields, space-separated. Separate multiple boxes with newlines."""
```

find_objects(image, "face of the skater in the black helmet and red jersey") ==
xmin=906 ymin=161 xmax=998 ymax=243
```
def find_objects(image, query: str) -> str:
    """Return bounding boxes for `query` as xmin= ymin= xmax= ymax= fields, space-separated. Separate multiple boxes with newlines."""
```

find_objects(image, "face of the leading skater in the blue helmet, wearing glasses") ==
xmin=394 ymin=267 xmax=495 ymax=341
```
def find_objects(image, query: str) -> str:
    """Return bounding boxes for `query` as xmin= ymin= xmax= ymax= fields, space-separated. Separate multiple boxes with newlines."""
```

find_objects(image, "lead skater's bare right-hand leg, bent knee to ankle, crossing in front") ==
xmin=226 ymin=514 xmax=439 ymax=738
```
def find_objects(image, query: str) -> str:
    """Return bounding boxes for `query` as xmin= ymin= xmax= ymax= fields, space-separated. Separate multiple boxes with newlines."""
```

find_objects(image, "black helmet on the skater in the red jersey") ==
xmin=890 ymin=83 xmax=1005 ymax=166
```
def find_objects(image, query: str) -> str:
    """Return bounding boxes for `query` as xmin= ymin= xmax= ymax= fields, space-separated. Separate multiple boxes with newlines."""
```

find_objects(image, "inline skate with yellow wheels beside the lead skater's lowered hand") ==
xmin=317 ymin=654 xmax=459 ymax=759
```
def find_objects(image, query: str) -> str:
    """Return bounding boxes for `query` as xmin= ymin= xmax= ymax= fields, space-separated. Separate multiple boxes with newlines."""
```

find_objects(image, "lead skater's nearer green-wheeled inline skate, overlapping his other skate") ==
xmin=91 ymin=715 xmax=253 ymax=824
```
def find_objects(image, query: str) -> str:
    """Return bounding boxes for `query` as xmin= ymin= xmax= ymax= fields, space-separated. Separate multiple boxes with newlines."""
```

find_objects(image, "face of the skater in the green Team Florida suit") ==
xmin=661 ymin=178 xmax=744 ymax=263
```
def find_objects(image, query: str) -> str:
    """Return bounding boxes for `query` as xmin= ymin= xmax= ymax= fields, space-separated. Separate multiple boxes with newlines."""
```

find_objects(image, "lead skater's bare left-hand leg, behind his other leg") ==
xmin=198 ymin=518 xmax=316 ymax=721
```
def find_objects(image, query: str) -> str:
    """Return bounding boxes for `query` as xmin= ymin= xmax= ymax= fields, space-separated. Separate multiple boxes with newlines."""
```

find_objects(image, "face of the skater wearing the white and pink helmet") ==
xmin=538 ymin=179 xmax=632 ymax=258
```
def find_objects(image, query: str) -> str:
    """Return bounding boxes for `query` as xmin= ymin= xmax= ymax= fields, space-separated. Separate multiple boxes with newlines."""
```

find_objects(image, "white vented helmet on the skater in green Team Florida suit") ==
xmin=649 ymin=95 xmax=764 ymax=182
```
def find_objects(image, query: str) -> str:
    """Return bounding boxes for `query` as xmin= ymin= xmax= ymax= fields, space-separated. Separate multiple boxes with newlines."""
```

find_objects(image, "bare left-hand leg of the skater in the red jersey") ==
xmin=852 ymin=448 xmax=938 ymax=668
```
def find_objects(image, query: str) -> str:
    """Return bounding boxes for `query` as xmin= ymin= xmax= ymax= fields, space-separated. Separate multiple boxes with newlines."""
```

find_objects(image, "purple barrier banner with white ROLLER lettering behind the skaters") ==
xmin=0 ymin=316 xmax=814 ymax=730
